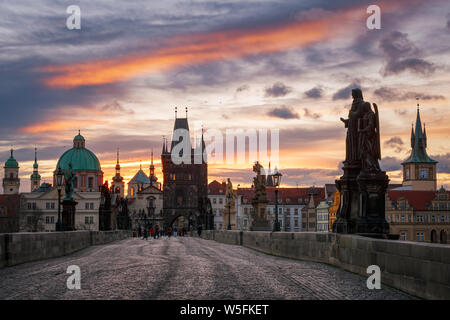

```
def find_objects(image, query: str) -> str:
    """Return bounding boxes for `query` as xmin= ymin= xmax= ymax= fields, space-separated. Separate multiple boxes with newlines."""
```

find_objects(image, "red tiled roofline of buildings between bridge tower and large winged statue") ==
xmin=238 ymin=187 xmax=325 ymax=206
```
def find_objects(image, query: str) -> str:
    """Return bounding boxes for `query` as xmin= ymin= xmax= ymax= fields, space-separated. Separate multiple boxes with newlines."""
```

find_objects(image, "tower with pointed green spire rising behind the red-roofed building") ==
xmin=402 ymin=103 xmax=438 ymax=191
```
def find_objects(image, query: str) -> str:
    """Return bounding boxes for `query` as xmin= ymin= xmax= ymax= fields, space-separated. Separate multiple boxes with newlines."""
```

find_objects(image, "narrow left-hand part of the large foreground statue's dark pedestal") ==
xmin=333 ymin=161 xmax=361 ymax=233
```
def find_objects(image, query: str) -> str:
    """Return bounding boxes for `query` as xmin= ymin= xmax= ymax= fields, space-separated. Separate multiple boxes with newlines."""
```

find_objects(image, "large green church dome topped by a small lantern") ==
xmin=56 ymin=134 xmax=101 ymax=171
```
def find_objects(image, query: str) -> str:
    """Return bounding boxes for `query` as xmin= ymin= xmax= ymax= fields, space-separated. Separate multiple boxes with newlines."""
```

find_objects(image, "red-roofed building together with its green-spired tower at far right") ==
xmin=386 ymin=108 xmax=450 ymax=243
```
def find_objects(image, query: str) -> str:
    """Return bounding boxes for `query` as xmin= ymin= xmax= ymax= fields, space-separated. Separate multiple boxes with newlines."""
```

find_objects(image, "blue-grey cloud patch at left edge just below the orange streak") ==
xmin=0 ymin=58 xmax=126 ymax=137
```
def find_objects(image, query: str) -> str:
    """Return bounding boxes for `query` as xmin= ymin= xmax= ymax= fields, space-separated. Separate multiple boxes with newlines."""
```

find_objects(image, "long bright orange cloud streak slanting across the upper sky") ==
xmin=40 ymin=0 xmax=415 ymax=88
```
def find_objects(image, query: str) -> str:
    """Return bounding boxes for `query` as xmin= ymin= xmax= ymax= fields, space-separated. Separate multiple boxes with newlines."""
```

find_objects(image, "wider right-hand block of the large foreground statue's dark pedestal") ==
xmin=356 ymin=171 xmax=389 ymax=238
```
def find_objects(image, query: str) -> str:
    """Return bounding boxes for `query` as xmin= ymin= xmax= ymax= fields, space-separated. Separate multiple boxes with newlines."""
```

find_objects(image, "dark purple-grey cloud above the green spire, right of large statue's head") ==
xmin=379 ymin=31 xmax=436 ymax=75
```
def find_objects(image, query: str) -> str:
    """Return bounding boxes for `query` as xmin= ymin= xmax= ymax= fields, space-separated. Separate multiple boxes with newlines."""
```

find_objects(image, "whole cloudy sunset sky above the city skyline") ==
xmin=0 ymin=0 xmax=450 ymax=191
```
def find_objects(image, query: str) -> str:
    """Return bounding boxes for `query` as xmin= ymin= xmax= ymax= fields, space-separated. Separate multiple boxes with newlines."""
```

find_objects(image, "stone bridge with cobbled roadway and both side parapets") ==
xmin=0 ymin=230 xmax=450 ymax=299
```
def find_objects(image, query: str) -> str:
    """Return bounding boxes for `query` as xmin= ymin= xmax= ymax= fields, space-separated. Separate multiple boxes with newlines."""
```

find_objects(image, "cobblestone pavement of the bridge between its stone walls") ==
xmin=0 ymin=237 xmax=411 ymax=300
